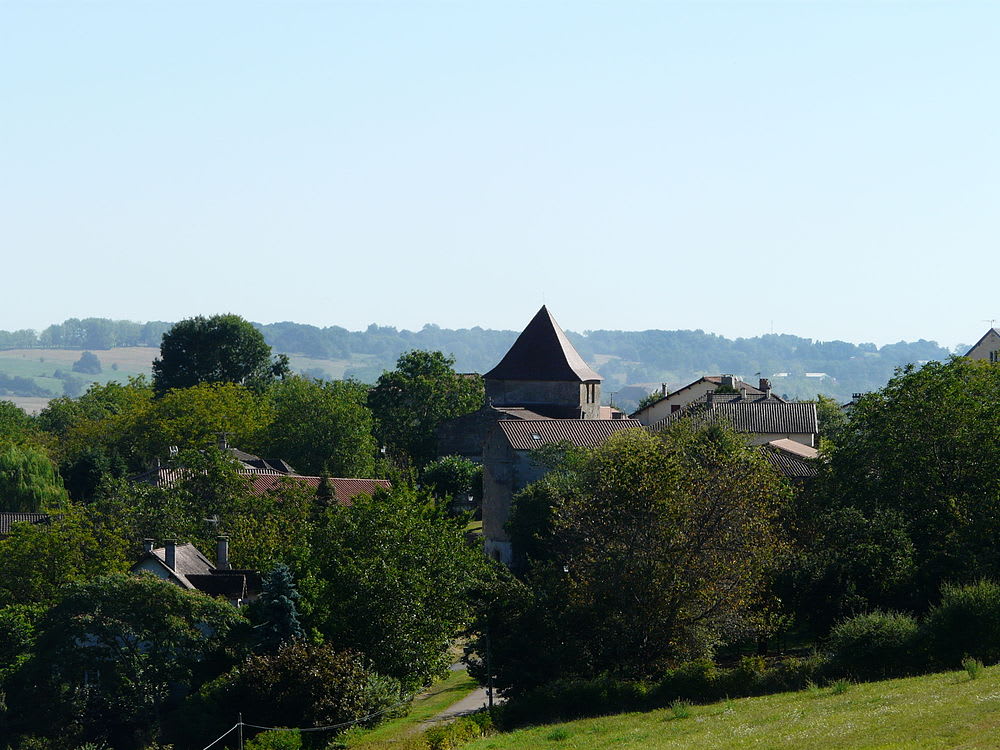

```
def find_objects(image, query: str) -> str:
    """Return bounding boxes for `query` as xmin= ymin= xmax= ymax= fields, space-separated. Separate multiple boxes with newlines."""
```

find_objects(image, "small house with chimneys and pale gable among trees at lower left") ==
xmin=132 ymin=536 xmax=261 ymax=607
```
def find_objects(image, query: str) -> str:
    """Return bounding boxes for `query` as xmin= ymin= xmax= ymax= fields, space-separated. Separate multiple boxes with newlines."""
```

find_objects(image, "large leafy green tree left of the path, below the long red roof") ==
xmin=310 ymin=486 xmax=488 ymax=687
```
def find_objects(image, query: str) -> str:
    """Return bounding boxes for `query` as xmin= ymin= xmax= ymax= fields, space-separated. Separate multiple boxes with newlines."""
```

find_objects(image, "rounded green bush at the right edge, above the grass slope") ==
xmin=924 ymin=580 xmax=1000 ymax=668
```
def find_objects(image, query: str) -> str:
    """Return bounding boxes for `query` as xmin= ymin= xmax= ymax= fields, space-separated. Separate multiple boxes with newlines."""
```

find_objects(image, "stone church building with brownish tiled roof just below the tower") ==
xmin=483 ymin=419 xmax=642 ymax=565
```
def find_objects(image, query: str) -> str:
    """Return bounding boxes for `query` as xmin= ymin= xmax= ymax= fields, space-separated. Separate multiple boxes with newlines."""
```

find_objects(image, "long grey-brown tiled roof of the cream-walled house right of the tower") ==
xmin=649 ymin=400 xmax=819 ymax=435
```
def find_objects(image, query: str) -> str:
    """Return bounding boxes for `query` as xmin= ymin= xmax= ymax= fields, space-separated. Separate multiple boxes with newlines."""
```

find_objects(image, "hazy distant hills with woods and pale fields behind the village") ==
xmin=0 ymin=318 xmax=951 ymax=410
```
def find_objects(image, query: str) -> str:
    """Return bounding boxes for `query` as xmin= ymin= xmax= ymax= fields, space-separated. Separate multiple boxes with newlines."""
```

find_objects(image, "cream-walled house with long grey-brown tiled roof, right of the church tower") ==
xmin=649 ymin=391 xmax=819 ymax=448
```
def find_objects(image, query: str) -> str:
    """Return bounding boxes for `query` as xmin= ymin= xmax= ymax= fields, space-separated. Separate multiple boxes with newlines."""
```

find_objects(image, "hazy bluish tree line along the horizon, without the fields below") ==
xmin=0 ymin=318 xmax=951 ymax=407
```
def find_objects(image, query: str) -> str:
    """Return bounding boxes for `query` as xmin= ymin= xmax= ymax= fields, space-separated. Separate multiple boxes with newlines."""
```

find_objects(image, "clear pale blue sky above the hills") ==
xmin=0 ymin=0 xmax=1000 ymax=346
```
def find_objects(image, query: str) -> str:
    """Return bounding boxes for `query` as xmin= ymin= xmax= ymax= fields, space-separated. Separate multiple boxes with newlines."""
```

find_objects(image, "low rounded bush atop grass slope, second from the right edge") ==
xmin=829 ymin=611 xmax=925 ymax=680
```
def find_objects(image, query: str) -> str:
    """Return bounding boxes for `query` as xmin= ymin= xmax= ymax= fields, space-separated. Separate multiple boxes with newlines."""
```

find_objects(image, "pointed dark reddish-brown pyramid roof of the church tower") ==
xmin=483 ymin=305 xmax=601 ymax=383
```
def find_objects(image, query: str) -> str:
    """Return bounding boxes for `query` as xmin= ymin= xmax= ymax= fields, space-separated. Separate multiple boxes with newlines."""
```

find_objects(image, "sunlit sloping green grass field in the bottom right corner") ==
xmin=463 ymin=666 xmax=1000 ymax=750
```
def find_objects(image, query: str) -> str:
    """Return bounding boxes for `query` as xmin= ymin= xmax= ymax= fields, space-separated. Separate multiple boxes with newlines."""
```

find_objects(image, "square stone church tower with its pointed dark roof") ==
xmin=483 ymin=305 xmax=601 ymax=419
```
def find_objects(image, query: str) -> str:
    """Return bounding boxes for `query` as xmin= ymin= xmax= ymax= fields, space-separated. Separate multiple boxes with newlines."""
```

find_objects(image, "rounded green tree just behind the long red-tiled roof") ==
xmin=256 ymin=377 xmax=377 ymax=477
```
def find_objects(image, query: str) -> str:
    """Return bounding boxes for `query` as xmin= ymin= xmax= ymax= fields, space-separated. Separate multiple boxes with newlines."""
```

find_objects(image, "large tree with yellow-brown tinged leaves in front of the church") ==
xmin=473 ymin=424 xmax=787 ymax=689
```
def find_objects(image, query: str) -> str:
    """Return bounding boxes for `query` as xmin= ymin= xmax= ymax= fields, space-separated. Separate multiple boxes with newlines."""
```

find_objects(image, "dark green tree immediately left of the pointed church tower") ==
xmin=368 ymin=350 xmax=485 ymax=466
